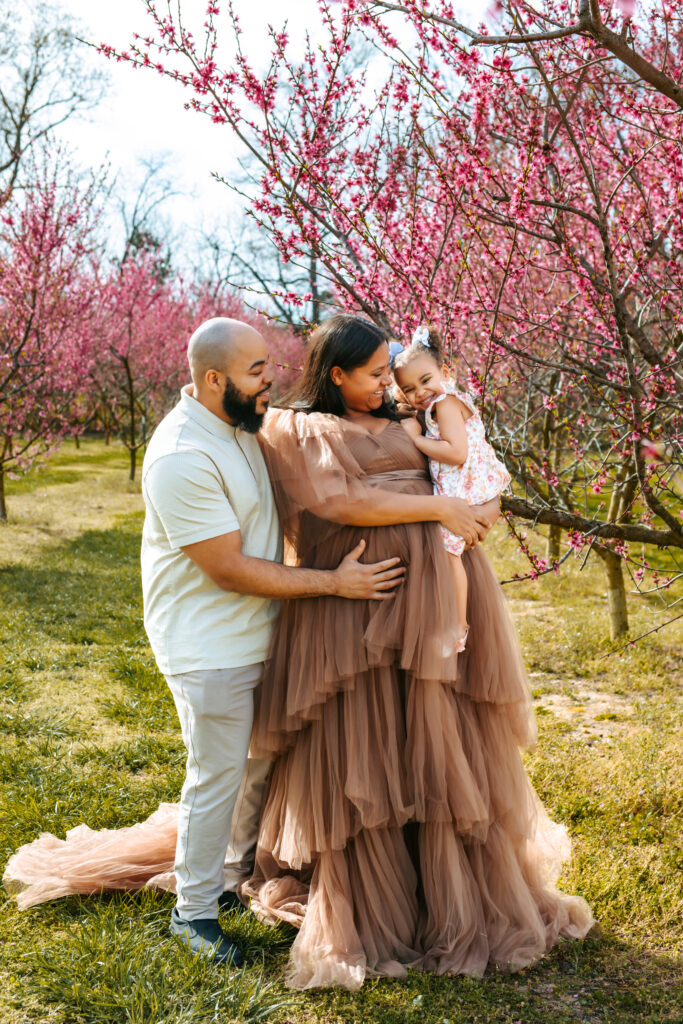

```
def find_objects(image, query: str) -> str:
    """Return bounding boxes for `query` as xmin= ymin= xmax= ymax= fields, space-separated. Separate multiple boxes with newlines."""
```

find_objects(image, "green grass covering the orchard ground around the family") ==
xmin=0 ymin=441 xmax=683 ymax=1024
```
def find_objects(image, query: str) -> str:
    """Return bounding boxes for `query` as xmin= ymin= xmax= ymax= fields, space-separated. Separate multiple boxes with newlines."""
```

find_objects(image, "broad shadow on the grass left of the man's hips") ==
xmin=0 ymin=513 xmax=175 ymax=708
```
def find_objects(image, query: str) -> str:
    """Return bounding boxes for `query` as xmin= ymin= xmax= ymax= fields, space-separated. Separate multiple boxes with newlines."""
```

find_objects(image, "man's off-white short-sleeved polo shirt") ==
xmin=141 ymin=385 xmax=283 ymax=675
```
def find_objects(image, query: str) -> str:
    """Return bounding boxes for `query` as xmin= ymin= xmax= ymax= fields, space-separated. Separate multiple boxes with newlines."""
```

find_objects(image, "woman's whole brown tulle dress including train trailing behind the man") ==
xmin=5 ymin=411 xmax=593 ymax=989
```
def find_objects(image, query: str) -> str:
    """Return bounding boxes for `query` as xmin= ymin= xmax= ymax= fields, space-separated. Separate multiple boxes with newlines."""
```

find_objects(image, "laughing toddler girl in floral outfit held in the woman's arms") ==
xmin=392 ymin=325 xmax=510 ymax=651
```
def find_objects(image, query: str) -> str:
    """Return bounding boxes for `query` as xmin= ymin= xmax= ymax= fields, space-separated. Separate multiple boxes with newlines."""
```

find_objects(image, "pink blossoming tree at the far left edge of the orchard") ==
xmin=0 ymin=163 xmax=98 ymax=519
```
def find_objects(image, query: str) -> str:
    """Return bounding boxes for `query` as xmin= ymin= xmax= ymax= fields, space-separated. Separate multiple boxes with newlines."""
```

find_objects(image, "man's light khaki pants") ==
xmin=166 ymin=663 xmax=270 ymax=921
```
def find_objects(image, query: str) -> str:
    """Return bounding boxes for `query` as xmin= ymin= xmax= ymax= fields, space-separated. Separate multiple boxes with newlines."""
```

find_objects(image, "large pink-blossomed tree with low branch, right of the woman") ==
xmin=102 ymin=0 xmax=683 ymax=635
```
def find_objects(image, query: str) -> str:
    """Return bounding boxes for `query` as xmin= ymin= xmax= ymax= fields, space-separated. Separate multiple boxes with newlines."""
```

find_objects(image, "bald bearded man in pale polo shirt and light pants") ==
xmin=141 ymin=317 xmax=403 ymax=966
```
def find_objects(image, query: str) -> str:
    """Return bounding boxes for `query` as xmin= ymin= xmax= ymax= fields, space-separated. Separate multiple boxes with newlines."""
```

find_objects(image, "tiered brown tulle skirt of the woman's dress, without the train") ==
xmin=243 ymin=540 xmax=593 ymax=989
